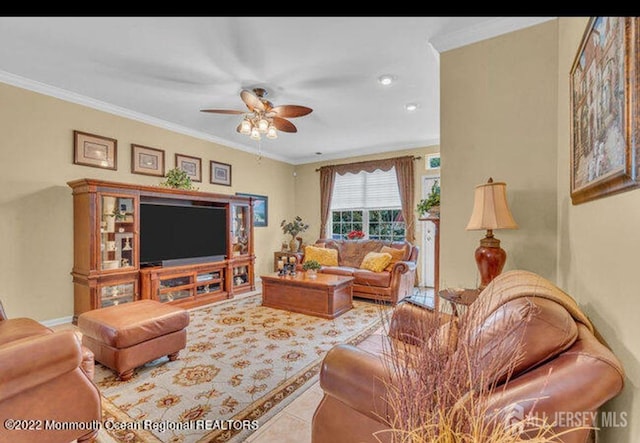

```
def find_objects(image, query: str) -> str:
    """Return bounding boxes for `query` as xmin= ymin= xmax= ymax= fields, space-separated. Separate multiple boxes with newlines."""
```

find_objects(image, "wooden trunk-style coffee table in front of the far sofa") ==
xmin=260 ymin=272 xmax=353 ymax=318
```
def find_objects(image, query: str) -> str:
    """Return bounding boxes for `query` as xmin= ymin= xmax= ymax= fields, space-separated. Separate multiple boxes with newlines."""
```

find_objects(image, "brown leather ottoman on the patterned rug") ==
xmin=78 ymin=300 xmax=189 ymax=380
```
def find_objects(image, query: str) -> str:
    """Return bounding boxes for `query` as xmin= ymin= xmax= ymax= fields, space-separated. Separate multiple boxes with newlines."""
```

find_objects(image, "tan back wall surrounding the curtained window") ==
xmin=291 ymin=146 xmax=439 ymax=248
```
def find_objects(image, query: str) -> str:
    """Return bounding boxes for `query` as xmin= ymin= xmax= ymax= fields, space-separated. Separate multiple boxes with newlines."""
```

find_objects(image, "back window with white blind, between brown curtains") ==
xmin=329 ymin=168 xmax=405 ymax=240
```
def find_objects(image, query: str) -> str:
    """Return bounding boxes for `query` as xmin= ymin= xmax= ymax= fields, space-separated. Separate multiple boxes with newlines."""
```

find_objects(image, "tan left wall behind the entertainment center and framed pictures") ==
xmin=0 ymin=83 xmax=294 ymax=320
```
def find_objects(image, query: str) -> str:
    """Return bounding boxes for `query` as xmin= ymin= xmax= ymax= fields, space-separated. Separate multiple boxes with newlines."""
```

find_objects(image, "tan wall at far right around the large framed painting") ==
xmin=557 ymin=18 xmax=640 ymax=443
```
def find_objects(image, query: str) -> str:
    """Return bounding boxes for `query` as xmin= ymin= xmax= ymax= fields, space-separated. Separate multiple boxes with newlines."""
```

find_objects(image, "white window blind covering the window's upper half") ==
xmin=331 ymin=168 xmax=401 ymax=211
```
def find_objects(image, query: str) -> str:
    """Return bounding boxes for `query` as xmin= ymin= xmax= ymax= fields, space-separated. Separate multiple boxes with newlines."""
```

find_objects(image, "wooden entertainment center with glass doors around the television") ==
xmin=68 ymin=178 xmax=255 ymax=323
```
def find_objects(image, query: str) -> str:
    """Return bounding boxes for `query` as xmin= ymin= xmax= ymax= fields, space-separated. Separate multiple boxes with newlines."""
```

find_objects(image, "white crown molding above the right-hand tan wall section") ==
xmin=429 ymin=17 xmax=557 ymax=53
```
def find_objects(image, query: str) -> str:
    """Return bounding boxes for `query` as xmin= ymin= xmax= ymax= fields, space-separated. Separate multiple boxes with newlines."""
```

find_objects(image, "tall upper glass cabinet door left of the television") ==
xmin=100 ymin=195 xmax=137 ymax=271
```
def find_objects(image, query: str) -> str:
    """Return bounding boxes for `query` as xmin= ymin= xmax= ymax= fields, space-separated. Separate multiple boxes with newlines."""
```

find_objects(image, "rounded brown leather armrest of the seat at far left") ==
xmin=0 ymin=331 xmax=82 ymax=401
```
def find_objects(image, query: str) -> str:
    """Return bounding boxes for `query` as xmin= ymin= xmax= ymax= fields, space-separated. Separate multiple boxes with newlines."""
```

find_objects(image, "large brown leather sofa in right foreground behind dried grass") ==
xmin=312 ymin=271 xmax=624 ymax=443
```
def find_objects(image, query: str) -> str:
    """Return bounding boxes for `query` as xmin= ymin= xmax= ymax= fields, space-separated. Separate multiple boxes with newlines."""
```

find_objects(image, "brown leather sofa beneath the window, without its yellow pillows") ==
xmin=302 ymin=239 xmax=418 ymax=304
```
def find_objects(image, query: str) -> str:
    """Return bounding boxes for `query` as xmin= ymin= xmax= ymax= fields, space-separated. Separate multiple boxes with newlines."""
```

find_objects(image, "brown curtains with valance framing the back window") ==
xmin=320 ymin=155 xmax=415 ymax=243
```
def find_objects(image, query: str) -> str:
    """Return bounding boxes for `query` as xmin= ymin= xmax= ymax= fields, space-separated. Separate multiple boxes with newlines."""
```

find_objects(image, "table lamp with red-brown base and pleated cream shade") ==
xmin=466 ymin=178 xmax=518 ymax=290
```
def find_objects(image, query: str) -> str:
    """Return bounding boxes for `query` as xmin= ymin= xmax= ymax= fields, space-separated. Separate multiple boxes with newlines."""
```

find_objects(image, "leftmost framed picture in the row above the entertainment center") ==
xmin=73 ymin=131 xmax=118 ymax=170
